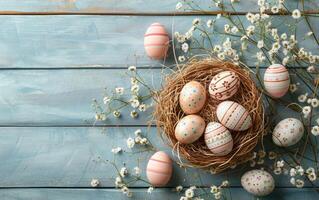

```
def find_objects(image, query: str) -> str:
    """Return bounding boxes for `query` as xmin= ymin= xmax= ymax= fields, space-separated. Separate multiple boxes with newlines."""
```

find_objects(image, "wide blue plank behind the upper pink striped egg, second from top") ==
xmin=0 ymin=15 xmax=319 ymax=68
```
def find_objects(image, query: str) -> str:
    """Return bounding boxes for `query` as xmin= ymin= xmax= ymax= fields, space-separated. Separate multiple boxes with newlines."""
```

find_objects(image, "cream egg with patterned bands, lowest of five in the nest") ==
xmin=204 ymin=122 xmax=233 ymax=156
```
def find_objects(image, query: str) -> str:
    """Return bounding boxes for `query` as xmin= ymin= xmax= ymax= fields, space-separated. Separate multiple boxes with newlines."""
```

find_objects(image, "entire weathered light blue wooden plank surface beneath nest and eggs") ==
xmin=0 ymin=0 xmax=319 ymax=200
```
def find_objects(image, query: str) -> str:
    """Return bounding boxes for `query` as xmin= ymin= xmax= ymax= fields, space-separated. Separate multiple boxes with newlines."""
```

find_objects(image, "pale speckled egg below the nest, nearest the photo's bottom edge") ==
xmin=241 ymin=169 xmax=275 ymax=196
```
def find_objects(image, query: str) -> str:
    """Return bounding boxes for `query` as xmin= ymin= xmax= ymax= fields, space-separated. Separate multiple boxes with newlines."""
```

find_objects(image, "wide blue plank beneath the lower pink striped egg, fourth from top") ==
xmin=0 ymin=127 xmax=318 ymax=188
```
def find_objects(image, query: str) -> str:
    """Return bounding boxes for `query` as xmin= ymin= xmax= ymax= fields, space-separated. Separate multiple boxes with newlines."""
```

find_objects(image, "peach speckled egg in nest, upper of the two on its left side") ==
xmin=179 ymin=81 xmax=206 ymax=114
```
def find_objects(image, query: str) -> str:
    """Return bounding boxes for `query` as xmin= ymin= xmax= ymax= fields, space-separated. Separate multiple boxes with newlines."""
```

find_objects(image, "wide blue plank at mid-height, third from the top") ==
xmin=0 ymin=69 xmax=312 ymax=126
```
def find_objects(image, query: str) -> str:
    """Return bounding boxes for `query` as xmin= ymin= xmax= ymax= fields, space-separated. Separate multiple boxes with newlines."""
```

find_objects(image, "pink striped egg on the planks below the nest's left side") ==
xmin=146 ymin=151 xmax=173 ymax=187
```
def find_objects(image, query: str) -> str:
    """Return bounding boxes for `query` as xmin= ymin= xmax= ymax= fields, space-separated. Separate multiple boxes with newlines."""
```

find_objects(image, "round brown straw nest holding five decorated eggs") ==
xmin=154 ymin=58 xmax=264 ymax=173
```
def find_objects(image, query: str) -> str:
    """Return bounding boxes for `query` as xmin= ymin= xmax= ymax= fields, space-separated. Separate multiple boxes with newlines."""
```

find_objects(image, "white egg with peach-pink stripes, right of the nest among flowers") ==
xmin=264 ymin=64 xmax=290 ymax=98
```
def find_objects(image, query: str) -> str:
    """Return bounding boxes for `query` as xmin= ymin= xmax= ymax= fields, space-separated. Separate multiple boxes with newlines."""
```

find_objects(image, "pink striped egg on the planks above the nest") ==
xmin=144 ymin=23 xmax=169 ymax=60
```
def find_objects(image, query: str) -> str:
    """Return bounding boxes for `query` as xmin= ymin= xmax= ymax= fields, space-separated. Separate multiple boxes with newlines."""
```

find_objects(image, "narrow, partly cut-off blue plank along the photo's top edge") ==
xmin=0 ymin=0 xmax=319 ymax=15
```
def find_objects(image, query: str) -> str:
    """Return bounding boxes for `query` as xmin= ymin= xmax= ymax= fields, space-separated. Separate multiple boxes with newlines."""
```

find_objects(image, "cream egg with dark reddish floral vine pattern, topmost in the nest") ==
xmin=209 ymin=71 xmax=240 ymax=100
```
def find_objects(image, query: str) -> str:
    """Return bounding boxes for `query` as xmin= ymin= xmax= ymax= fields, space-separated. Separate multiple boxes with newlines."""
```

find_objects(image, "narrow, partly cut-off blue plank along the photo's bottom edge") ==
xmin=0 ymin=188 xmax=319 ymax=200
